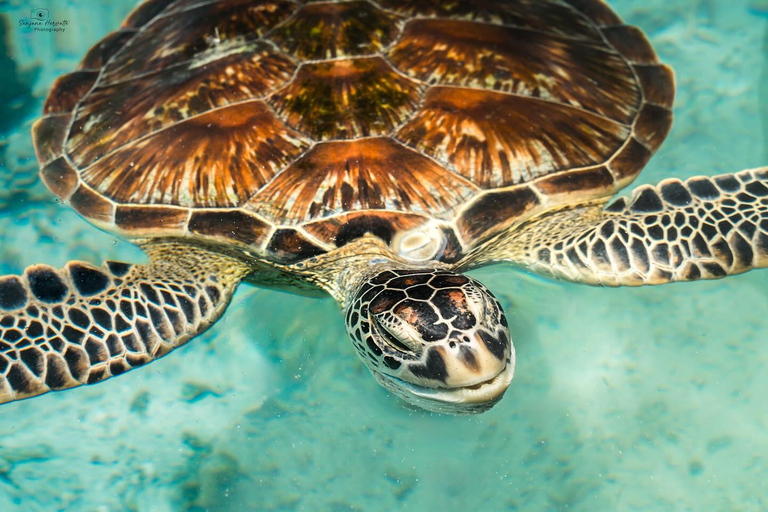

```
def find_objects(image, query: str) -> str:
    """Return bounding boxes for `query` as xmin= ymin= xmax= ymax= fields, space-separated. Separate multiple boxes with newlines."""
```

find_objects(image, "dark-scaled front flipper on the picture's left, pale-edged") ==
xmin=0 ymin=244 xmax=248 ymax=403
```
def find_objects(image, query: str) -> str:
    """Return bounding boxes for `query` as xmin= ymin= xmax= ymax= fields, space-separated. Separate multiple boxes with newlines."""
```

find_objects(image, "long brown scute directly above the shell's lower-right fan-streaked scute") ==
xmin=390 ymin=19 xmax=641 ymax=123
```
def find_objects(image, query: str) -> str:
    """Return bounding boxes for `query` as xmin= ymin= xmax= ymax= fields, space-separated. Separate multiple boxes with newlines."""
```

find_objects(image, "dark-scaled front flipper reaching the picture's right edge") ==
xmin=486 ymin=167 xmax=768 ymax=286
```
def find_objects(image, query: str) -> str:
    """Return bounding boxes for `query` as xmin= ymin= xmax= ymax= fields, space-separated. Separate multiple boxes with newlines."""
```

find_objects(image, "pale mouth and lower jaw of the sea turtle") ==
xmin=374 ymin=351 xmax=515 ymax=414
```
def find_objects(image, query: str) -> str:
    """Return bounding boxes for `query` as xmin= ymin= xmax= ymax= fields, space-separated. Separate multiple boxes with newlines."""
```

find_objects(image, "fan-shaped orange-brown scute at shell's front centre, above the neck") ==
xmin=246 ymin=138 xmax=477 ymax=224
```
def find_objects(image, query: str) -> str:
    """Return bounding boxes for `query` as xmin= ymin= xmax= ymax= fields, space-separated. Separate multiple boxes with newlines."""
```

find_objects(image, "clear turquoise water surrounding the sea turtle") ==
xmin=0 ymin=0 xmax=768 ymax=512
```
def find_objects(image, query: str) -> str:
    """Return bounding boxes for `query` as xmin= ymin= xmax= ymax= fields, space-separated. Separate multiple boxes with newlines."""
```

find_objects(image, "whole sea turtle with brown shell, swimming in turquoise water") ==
xmin=0 ymin=0 xmax=768 ymax=413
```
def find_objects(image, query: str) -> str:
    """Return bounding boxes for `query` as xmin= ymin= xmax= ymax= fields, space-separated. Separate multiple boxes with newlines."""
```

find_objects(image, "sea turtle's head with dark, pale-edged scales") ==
xmin=346 ymin=270 xmax=515 ymax=414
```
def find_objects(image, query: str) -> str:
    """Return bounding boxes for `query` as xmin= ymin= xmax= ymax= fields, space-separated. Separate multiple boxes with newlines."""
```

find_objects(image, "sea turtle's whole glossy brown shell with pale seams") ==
xmin=33 ymin=0 xmax=674 ymax=263
